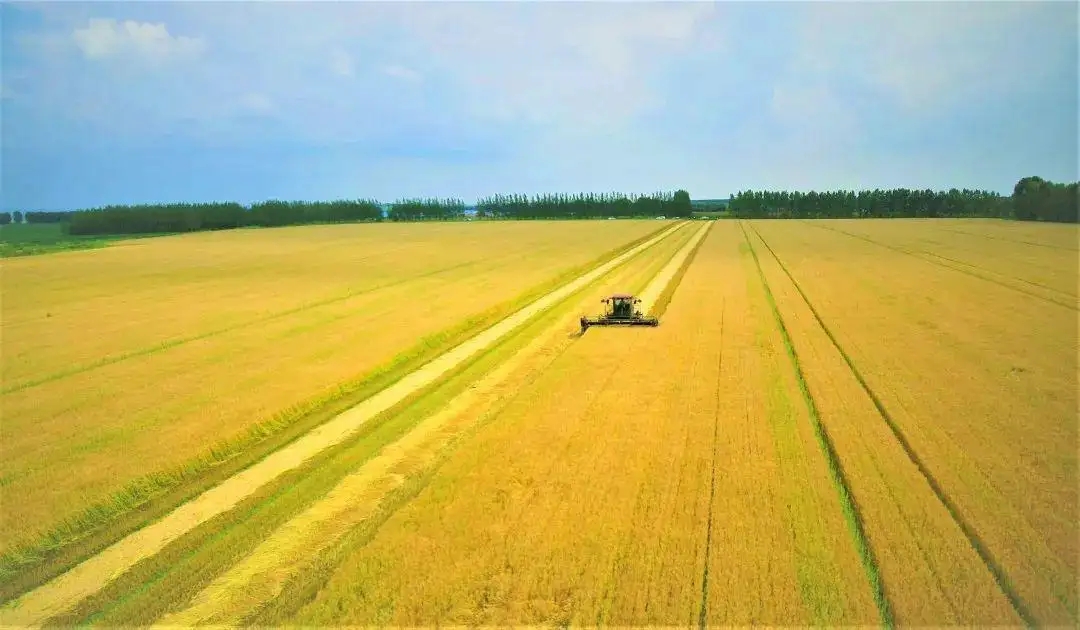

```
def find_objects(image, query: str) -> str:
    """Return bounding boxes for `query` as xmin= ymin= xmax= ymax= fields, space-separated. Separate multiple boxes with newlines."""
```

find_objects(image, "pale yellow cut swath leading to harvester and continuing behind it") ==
xmin=158 ymin=219 xmax=711 ymax=627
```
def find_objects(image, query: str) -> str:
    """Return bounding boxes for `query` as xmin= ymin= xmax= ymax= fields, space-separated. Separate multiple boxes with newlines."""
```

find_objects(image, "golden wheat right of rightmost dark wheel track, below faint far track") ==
xmin=754 ymin=222 xmax=1080 ymax=625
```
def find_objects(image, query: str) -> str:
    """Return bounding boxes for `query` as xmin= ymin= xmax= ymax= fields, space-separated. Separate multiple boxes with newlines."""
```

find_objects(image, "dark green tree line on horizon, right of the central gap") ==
xmin=728 ymin=177 xmax=1080 ymax=223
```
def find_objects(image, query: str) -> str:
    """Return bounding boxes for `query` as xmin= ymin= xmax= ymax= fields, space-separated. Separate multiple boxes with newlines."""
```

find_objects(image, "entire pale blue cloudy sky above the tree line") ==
xmin=0 ymin=1 xmax=1078 ymax=210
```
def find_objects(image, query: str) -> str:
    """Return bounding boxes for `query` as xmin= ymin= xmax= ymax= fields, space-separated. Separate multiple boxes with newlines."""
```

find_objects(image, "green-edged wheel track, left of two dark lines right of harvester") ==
xmin=739 ymin=220 xmax=895 ymax=628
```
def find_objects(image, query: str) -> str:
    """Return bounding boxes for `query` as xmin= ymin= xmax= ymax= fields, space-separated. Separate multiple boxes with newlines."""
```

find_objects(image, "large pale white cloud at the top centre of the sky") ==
xmin=397 ymin=2 xmax=714 ymax=131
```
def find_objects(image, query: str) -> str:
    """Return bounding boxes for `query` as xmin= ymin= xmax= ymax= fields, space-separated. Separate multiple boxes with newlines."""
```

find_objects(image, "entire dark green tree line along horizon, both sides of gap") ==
xmin=0 ymin=176 xmax=1080 ymax=234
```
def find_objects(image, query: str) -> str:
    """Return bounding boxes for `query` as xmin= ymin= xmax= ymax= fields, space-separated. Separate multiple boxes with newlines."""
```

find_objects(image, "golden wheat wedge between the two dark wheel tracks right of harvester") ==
xmin=752 ymin=224 xmax=1023 ymax=626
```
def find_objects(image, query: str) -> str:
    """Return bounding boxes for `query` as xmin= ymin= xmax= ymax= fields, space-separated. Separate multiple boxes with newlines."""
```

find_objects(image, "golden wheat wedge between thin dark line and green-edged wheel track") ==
xmin=710 ymin=225 xmax=879 ymax=626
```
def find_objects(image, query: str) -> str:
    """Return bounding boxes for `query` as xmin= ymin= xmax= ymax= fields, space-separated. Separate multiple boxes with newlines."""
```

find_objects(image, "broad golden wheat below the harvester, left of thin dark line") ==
xmin=283 ymin=262 xmax=715 ymax=626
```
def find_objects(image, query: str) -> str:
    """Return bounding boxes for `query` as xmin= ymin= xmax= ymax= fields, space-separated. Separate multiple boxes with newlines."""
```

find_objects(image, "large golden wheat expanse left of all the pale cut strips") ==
xmin=0 ymin=222 xmax=657 ymax=548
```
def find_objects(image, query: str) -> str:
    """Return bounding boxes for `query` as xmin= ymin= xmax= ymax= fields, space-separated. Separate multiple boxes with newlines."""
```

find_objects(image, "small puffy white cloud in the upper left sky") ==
xmin=71 ymin=18 xmax=206 ymax=61
